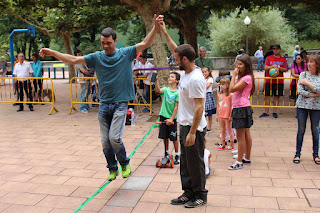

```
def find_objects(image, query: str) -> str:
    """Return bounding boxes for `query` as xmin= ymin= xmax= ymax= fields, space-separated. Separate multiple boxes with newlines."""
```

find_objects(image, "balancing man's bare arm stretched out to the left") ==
xmin=39 ymin=48 xmax=87 ymax=65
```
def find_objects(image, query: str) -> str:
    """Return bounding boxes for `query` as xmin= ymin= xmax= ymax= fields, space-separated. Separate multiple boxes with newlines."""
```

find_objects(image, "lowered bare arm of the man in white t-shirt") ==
xmin=186 ymin=98 xmax=204 ymax=146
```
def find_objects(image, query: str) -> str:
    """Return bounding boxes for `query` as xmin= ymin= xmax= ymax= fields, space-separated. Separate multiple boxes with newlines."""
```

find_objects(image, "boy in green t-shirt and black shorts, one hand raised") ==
xmin=155 ymin=72 xmax=180 ymax=165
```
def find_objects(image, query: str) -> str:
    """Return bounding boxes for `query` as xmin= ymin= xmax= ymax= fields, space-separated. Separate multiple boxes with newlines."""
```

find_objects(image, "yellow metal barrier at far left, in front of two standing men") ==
xmin=0 ymin=77 xmax=58 ymax=115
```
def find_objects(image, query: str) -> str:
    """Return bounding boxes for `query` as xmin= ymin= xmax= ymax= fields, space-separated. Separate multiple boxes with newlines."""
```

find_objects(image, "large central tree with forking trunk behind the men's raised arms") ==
xmin=121 ymin=0 xmax=171 ymax=86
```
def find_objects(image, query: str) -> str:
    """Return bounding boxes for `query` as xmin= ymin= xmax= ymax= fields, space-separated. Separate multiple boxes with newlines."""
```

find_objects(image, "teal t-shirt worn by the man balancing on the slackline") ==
xmin=84 ymin=46 xmax=137 ymax=103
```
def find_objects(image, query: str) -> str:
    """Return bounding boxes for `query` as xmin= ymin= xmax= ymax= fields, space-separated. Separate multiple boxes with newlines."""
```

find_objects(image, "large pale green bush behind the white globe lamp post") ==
xmin=208 ymin=8 xmax=297 ymax=56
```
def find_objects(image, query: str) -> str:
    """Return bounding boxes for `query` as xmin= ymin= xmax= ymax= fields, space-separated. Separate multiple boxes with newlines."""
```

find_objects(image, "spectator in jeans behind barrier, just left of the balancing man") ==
xmin=75 ymin=50 xmax=94 ymax=113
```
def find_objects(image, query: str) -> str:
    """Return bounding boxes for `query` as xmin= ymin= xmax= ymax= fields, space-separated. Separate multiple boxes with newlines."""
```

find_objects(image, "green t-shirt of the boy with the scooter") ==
xmin=160 ymin=87 xmax=179 ymax=118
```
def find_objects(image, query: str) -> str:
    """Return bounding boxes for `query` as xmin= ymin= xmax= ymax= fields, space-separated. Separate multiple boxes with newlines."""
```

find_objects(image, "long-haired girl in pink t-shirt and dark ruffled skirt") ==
xmin=229 ymin=54 xmax=255 ymax=170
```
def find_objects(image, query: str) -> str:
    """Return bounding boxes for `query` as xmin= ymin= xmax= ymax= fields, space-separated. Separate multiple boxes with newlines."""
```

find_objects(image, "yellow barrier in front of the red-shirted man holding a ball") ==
xmin=250 ymin=77 xmax=298 ymax=108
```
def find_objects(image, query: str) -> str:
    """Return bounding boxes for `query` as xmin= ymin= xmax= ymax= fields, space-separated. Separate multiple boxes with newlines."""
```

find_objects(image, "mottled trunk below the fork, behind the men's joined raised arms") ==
xmin=139 ymin=11 xmax=169 ymax=87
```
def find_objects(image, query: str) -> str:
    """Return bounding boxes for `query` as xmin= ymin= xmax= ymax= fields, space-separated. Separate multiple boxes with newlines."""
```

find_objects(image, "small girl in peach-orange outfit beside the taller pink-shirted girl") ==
xmin=216 ymin=78 xmax=234 ymax=151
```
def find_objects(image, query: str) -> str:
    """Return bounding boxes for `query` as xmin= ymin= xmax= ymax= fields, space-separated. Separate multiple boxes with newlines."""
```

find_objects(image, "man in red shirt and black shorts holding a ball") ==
xmin=259 ymin=44 xmax=288 ymax=118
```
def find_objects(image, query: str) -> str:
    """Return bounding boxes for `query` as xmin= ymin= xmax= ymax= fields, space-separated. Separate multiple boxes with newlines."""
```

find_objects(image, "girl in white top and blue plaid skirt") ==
xmin=201 ymin=66 xmax=216 ymax=133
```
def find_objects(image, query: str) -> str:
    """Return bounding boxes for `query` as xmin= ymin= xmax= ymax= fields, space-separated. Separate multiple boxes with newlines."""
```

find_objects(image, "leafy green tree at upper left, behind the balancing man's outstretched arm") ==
xmin=0 ymin=0 xmax=132 ymax=79
